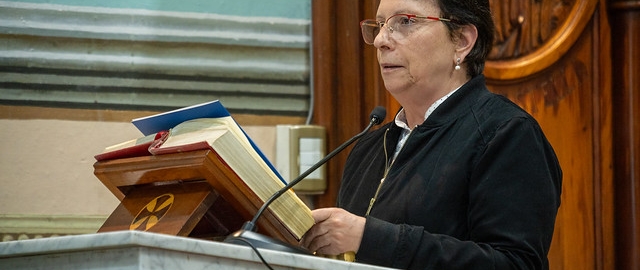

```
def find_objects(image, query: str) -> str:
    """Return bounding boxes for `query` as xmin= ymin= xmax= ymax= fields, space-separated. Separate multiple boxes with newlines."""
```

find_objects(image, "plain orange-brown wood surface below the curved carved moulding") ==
xmin=489 ymin=12 xmax=610 ymax=269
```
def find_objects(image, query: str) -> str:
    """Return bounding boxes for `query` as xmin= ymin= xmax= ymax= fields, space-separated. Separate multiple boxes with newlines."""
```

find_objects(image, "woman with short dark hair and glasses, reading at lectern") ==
xmin=301 ymin=0 xmax=562 ymax=269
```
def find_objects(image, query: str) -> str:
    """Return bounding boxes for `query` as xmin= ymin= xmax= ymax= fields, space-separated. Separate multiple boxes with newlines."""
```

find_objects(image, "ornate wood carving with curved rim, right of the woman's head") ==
xmin=484 ymin=0 xmax=598 ymax=80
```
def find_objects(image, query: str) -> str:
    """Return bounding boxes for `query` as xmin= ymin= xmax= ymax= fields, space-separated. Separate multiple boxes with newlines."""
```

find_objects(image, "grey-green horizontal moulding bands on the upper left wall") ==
xmin=0 ymin=1 xmax=310 ymax=116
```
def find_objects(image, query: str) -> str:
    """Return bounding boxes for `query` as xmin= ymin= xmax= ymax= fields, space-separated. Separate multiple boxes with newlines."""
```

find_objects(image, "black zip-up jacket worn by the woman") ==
xmin=338 ymin=75 xmax=562 ymax=269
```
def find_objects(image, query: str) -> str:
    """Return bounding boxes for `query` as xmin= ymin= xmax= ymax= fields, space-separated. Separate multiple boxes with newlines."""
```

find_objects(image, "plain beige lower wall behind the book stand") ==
xmin=0 ymin=119 xmax=275 ymax=240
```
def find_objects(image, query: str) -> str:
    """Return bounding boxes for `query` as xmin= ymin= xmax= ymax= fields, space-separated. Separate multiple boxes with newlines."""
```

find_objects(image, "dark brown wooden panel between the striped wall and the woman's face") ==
xmin=312 ymin=0 xmax=386 ymax=207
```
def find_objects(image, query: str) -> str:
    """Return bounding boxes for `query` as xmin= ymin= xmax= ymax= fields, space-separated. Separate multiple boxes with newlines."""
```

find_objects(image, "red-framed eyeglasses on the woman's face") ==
xmin=360 ymin=14 xmax=455 ymax=45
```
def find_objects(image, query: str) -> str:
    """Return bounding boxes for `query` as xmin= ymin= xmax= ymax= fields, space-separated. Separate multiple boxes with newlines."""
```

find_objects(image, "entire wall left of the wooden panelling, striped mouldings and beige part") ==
xmin=0 ymin=0 xmax=310 ymax=241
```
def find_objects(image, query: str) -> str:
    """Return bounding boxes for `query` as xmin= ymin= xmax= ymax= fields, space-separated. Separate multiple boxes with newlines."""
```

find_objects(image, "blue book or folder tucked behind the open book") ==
xmin=131 ymin=100 xmax=287 ymax=185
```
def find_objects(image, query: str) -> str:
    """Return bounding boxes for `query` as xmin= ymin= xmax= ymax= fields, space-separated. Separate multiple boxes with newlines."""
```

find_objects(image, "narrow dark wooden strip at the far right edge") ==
xmin=611 ymin=0 xmax=640 ymax=270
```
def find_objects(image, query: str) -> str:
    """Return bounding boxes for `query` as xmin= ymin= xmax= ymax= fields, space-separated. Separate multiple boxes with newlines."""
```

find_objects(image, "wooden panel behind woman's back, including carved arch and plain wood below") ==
xmin=486 ymin=1 xmax=615 ymax=269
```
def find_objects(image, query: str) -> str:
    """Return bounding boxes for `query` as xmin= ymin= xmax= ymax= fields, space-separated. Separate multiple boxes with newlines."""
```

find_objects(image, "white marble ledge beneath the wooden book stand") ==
xmin=0 ymin=231 xmax=398 ymax=270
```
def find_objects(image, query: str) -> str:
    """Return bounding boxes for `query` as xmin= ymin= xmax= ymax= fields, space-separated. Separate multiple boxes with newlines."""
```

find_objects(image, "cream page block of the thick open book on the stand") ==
xmin=149 ymin=116 xmax=314 ymax=239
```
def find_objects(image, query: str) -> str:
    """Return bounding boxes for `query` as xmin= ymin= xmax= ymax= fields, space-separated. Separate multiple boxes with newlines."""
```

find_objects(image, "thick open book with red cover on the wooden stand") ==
xmin=96 ymin=103 xmax=314 ymax=239
